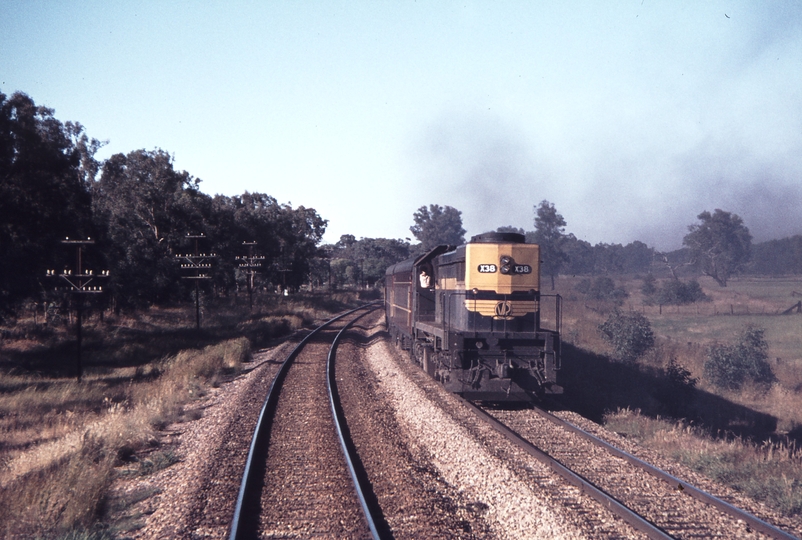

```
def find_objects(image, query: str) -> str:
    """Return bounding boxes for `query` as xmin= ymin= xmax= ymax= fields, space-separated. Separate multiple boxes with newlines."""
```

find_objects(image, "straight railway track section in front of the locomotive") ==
xmin=478 ymin=402 xmax=796 ymax=540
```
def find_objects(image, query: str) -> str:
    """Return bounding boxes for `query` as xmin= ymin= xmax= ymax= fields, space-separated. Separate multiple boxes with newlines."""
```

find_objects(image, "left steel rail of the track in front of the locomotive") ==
xmin=459 ymin=398 xmax=673 ymax=540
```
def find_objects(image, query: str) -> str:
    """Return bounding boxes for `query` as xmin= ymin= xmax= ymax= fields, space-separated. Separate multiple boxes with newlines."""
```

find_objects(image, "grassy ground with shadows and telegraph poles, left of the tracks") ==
xmin=0 ymin=294 xmax=357 ymax=540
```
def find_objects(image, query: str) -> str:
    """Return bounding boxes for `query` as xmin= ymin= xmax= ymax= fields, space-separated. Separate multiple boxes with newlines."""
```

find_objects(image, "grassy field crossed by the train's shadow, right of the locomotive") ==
xmin=557 ymin=277 xmax=802 ymax=517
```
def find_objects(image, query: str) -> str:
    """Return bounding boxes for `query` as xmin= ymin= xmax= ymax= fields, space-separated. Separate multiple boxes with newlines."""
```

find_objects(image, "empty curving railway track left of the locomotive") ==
xmin=229 ymin=305 xmax=381 ymax=540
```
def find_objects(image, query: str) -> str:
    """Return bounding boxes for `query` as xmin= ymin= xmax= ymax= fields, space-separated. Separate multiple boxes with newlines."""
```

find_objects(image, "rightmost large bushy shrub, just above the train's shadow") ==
xmin=704 ymin=325 xmax=776 ymax=390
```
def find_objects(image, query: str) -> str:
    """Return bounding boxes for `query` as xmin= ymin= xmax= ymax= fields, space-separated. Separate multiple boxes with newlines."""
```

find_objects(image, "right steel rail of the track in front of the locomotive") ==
xmin=533 ymin=407 xmax=798 ymax=540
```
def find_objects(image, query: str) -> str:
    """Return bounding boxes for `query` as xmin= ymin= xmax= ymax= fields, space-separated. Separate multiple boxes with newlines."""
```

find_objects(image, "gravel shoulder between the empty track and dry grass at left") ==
xmin=109 ymin=342 xmax=294 ymax=539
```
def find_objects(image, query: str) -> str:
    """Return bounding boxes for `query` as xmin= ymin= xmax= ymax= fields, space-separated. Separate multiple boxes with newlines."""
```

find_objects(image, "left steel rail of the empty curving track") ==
xmin=228 ymin=304 xmax=373 ymax=540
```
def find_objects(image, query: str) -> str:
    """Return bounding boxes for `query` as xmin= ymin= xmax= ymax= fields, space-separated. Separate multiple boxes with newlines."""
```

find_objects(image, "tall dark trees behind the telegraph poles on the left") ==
xmin=0 ymin=92 xmax=327 ymax=315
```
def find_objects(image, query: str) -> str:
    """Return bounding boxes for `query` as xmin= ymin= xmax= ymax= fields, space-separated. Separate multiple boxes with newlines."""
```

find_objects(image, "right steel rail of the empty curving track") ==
xmin=326 ymin=306 xmax=391 ymax=540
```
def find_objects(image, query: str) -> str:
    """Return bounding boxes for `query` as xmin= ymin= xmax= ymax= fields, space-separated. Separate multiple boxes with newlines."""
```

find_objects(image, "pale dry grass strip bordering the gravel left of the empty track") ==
xmin=0 ymin=338 xmax=250 ymax=536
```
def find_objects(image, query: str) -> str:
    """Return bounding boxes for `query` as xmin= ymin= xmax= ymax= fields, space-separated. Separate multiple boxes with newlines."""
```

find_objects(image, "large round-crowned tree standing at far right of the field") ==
xmin=682 ymin=209 xmax=752 ymax=287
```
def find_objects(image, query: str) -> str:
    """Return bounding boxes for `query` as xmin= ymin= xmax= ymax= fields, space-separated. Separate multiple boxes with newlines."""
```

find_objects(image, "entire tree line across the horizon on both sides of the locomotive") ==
xmin=0 ymin=88 xmax=802 ymax=314
